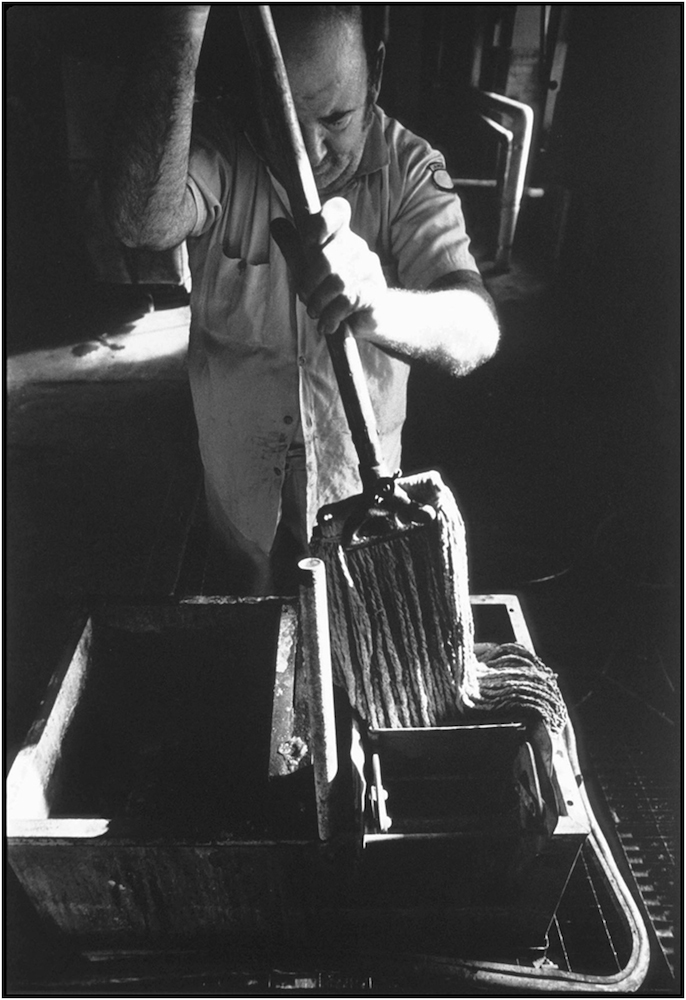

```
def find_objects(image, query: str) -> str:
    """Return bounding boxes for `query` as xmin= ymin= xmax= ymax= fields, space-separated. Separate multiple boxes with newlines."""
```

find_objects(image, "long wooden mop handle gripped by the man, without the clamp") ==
xmin=239 ymin=4 xmax=389 ymax=488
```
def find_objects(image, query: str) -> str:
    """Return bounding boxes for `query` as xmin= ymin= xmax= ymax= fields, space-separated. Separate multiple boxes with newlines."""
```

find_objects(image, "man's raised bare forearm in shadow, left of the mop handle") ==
xmin=103 ymin=4 xmax=209 ymax=250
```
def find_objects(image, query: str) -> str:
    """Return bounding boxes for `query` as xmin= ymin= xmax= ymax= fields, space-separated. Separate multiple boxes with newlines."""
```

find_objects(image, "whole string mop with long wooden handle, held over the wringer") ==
xmin=241 ymin=5 xmax=566 ymax=731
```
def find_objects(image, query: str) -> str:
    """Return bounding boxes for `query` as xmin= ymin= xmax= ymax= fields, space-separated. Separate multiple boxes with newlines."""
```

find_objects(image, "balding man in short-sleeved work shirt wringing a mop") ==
xmin=108 ymin=4 xmax=498 ymax=594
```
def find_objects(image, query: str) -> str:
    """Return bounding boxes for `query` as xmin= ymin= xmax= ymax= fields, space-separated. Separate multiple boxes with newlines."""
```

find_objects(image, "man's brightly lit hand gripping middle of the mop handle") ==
xmin=272 ymin=198 xmax=388 ymax=340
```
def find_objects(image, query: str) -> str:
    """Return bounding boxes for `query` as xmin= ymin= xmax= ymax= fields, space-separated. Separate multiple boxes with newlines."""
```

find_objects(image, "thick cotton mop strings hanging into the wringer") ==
xmin=311 ymin=472 xmax=567 ymax=732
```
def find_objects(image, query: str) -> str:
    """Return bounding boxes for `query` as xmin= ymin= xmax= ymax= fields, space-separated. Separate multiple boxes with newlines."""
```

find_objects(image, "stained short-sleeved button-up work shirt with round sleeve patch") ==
xmin=188 ymin=108 xmax=477 ymax=551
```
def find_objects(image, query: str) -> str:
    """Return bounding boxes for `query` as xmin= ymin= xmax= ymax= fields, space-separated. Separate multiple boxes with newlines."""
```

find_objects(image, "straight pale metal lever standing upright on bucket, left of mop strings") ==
xmin=298 ymin=559 xmax=338 ymax=840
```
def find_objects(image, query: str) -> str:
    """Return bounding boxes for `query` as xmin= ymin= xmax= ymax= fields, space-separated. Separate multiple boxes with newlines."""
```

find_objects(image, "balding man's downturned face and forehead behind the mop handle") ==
xmin=283 ymin=22 xmax=370 ymax=197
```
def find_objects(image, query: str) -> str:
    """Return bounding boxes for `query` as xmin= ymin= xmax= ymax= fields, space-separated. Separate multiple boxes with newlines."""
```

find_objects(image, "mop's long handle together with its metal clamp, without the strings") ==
xmin=241 ymin=4 xmax=435 ymax=545
